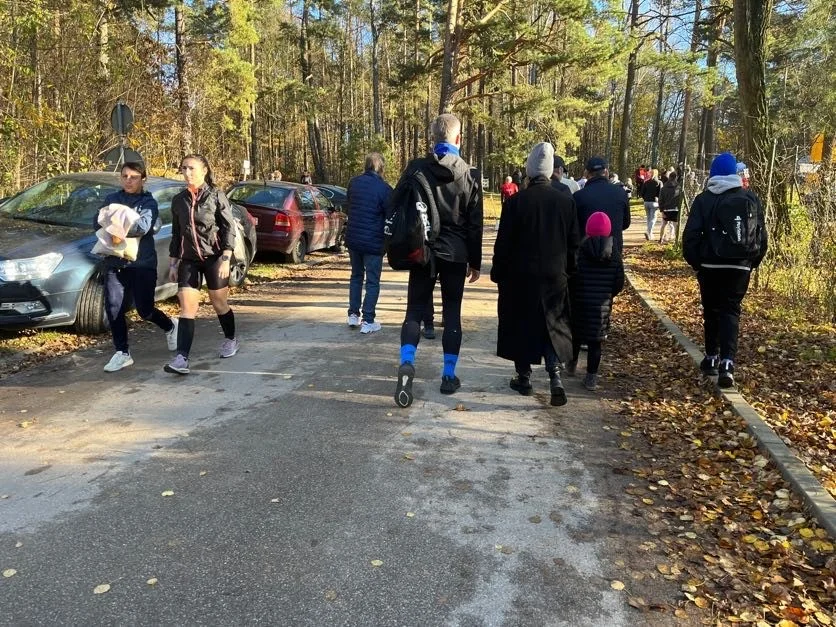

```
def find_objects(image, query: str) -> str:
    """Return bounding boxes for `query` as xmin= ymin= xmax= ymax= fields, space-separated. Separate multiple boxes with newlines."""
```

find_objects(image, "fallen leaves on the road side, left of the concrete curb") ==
xmin=606 ymin=286 xmax=836 ymax=627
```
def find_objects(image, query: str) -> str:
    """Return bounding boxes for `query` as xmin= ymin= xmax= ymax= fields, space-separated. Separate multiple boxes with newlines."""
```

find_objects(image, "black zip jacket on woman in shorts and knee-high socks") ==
xmin=168 ymin=183 xmax=235 ymax=261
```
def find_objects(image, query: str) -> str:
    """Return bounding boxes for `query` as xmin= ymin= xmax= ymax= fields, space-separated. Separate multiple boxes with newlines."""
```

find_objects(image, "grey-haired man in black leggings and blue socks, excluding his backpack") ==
xmin=395 ymin=113 xmax=482 ymax=407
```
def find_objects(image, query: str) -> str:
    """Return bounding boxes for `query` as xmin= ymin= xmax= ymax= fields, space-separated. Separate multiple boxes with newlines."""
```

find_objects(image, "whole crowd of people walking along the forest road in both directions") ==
xmin=90 ymin=114 xmax=767 ymax=407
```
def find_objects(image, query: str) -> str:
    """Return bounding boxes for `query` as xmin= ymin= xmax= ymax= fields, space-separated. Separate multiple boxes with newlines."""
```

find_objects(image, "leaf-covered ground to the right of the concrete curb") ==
xmin=628 ymin=245 xmax=836 ymax=497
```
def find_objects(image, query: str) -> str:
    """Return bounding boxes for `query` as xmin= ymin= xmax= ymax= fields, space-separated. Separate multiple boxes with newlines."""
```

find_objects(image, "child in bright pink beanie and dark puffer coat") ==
xmin=566 ymin=211 xmax=624 ymax=390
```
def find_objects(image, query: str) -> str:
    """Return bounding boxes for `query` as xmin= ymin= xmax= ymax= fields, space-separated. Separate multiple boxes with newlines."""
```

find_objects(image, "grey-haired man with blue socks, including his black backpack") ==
xmin=384 ymin=113 xmax=483 ymax=407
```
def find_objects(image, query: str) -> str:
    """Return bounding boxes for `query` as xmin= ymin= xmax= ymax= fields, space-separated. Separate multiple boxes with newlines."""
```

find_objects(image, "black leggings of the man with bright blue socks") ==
xmin=401 ymin=259 xmax=467 ymax=355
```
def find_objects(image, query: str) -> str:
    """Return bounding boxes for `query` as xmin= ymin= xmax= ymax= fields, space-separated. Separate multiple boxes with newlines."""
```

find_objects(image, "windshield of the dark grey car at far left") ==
xmin=0 ymin=177 xmax=119 ymax=229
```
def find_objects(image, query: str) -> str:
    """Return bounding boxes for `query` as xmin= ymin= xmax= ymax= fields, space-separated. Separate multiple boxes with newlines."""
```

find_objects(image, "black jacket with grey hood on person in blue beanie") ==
xmin=682 ymin=174 xmax=768 ymax=271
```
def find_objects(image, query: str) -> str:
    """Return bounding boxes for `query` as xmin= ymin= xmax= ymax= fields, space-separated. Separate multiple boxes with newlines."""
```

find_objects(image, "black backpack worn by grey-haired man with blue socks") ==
xmin=383 ymin=166 xmax=441 ymax=270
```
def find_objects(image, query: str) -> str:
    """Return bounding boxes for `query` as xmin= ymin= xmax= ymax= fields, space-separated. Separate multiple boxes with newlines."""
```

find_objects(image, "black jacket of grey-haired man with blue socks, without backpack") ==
xmin=398 ymin=153 xmax=483 ymax=270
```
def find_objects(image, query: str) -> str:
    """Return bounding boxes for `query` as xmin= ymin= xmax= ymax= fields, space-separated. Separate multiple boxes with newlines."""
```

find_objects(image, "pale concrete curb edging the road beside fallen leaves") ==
xmin=626 ymin=269 xmax=836 ymax=538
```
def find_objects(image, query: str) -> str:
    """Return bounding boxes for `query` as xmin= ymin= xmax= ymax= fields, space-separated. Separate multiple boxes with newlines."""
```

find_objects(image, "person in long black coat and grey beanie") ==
xmin=491 ymin=143 xmax=579 ymax=406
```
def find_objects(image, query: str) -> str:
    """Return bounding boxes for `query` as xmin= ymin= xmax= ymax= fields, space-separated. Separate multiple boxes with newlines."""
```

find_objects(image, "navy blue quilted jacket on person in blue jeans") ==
xmin=345 ymin=170 xmax=392 ymax=255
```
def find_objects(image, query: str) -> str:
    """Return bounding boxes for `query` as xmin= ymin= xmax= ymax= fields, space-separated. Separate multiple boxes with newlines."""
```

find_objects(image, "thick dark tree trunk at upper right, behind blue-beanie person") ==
xmin=734 ymin=0 xmax=790 ymax=228
